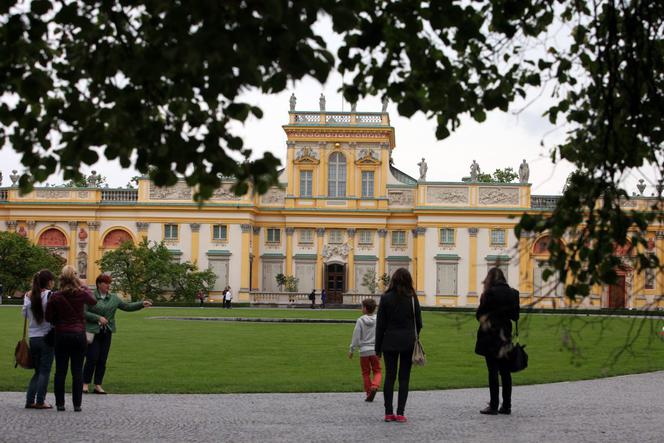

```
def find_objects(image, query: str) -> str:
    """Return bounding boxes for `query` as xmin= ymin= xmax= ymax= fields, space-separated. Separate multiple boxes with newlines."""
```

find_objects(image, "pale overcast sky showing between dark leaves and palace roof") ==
xmin=0 ymin=16 xmax=655 ymax=195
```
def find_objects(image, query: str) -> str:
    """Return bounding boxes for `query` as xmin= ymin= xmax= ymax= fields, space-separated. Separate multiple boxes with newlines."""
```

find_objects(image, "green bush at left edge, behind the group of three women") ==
xmin=0 ymin=232 xmax=65 ymax=297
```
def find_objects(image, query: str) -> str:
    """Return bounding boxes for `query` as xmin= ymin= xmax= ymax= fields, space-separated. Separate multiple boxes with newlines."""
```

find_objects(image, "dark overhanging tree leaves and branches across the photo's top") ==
xmin=0 ymin=0 xmax=664 ymax=296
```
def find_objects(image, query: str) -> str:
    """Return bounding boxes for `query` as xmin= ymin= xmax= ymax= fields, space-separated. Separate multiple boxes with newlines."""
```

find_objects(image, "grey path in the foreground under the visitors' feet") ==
xmin=0 ymin=369 xmax=664 ymax=443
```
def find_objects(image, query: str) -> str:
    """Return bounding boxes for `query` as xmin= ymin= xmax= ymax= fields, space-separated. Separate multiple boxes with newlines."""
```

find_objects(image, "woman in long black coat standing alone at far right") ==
xmin=475 ymin=268 xmax=519 ymax=415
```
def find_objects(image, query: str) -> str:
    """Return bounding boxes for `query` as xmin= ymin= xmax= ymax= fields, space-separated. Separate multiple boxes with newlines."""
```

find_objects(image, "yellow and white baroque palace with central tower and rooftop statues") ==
xmin=0 ymin=106 xmax=664 ymax=308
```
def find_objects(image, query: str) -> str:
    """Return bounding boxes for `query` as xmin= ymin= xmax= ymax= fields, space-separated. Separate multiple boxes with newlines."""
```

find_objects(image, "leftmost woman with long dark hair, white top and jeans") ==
xmin=23 ymin=269 xmax=55 ymax=409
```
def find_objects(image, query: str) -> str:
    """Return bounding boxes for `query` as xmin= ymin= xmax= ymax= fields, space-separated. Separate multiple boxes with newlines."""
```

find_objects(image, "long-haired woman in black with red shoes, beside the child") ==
xmin=376 ymin=268 xmax=422 ymax=423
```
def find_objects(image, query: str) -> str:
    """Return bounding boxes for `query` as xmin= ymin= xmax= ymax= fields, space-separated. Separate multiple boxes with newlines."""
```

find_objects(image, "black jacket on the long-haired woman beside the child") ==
xmin=376 ymin=292 xmax=422 ymax=354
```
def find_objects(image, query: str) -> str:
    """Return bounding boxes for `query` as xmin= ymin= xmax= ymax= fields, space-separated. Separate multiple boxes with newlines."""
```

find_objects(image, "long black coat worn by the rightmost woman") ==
xmin=475 ymin=283 xmax=519 ymax=357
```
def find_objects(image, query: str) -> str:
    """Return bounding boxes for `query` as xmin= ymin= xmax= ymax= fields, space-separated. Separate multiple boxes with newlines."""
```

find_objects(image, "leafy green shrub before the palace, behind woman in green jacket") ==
xmin=99 ymin=239 xmax=216 ymax=301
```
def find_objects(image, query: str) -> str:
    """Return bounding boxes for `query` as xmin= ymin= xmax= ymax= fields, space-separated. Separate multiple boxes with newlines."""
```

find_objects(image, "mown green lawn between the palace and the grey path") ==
xmin=0 ymin=307 xmax=664 ymax=393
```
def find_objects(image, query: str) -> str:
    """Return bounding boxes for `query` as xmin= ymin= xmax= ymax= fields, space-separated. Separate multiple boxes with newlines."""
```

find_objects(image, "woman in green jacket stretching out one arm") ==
xmin=83 ymin=274 xmax=152 ymax=394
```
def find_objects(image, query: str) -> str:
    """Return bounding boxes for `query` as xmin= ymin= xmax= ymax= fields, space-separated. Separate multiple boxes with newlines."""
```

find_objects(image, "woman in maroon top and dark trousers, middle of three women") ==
xmin=46 ymin=266 xmax=97 ymax=412
